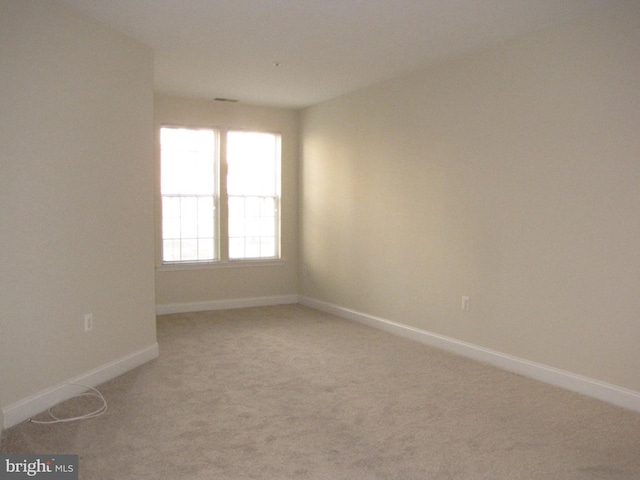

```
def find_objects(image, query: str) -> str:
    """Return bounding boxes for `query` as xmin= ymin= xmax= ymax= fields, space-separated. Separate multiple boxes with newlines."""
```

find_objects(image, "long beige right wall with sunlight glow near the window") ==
xmin=300 ymin=2 xmax=640 ymax=391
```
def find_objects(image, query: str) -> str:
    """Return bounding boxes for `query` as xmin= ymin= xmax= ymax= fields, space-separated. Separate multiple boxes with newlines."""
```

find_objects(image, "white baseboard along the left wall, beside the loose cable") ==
xmin=0 ymin=343 xmax=160 ymax=429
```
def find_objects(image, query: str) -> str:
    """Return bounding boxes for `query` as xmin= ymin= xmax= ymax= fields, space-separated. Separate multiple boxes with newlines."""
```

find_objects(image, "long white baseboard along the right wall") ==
xmin=299 ymin=296 xmax=640 ymax=412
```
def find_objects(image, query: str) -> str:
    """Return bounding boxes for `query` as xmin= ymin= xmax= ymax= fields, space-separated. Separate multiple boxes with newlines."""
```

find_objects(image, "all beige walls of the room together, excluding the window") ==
xmin=0 ymin=0 xmax=640 ymax=423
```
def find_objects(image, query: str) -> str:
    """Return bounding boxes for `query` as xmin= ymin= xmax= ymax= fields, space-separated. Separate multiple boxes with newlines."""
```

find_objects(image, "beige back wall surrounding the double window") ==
xmin=155 ymin=96 xmax=299 ymax=308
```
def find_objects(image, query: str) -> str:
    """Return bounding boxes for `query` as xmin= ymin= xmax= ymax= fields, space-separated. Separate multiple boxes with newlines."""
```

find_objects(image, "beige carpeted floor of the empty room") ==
xmin=1 ymin=305 xmax=640 ymax=480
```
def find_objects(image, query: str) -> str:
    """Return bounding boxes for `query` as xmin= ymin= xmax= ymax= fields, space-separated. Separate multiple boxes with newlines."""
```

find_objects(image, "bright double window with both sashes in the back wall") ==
xmin=160 ymin=127 xmax=280 ymax=264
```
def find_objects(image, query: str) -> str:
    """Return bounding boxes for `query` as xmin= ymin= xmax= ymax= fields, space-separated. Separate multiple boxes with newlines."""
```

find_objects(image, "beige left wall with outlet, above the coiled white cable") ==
xmin=0 ymin=0 xmax=156 ymax=407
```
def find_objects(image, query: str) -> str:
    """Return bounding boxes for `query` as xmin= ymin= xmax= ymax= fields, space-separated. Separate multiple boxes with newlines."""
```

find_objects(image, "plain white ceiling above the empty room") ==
xmin=61 ymin=0 xmax=612 ymax=108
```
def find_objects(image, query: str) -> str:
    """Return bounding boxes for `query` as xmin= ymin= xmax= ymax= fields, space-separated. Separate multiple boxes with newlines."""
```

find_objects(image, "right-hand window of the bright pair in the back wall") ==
xmin=227 ymin=131 xmax=280 ymax=260
